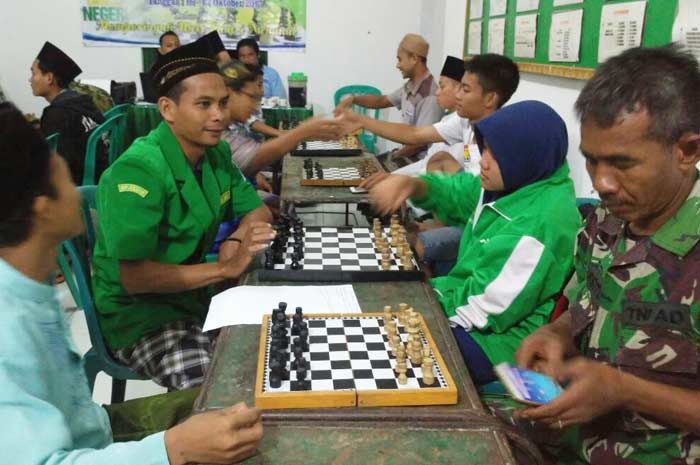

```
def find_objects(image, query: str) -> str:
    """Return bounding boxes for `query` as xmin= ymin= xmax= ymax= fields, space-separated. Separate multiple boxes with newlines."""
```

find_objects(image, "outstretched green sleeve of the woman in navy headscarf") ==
xmin=411 ymin=173 xmax=481 ymax=226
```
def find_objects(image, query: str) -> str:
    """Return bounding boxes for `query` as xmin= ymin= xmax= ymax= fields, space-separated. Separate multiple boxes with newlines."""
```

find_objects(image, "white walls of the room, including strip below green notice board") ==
xmin=0 ymin=0 xmax=591 ymax=196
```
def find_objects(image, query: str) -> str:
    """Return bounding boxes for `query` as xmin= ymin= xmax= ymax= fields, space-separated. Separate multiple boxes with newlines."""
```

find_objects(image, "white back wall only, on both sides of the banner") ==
xmin=0 ymin=0 xmax=423 ymax=115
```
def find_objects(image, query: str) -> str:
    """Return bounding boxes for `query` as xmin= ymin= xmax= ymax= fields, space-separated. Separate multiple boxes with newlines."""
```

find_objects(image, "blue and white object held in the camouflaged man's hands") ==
xmin=493 ymin=362 xmax=562 ymax=405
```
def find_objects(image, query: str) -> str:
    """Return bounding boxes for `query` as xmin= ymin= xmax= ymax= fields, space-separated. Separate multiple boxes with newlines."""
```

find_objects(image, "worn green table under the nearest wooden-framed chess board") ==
xmin=195 ymin=273 xmax=515 ymax=465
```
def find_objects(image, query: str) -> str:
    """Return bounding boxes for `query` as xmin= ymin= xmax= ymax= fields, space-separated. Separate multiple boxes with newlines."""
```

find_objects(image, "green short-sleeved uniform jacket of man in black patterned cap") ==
xmin=93 ymin=122 xmax=261 ymax=349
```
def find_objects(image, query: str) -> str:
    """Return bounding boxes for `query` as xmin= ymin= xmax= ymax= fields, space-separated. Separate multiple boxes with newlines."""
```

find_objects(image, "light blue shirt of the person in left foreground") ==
xmin=0 ymin=260 xmax=169 ymax=465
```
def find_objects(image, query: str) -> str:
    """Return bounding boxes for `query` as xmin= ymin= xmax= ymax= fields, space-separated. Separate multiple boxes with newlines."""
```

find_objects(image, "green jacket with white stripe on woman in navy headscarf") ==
xmin=415 ymin=164 xmax=581 ymax=364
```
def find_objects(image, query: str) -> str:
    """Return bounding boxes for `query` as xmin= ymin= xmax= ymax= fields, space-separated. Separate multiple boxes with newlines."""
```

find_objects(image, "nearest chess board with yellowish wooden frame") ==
xmin=255 ymin=313 xmax=457 ymax=409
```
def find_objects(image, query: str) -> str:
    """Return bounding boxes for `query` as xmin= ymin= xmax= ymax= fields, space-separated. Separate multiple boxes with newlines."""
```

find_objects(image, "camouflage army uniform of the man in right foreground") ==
xmin=562 ymin=175 xmax=700 ymax=465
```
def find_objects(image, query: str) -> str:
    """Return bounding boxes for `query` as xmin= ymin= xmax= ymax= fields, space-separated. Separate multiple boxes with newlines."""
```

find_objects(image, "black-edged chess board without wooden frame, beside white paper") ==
xmin=258 ymin=227 xmax=423 ymax=282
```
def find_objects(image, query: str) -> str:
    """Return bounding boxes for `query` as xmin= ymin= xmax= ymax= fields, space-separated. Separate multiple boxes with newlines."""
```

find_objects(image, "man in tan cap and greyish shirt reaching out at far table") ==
xmin=335 ymin=34 xmax=444 ymax=166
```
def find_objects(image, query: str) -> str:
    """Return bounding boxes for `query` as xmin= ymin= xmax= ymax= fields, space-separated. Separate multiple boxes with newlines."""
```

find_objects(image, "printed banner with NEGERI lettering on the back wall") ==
xmin=80 ymin=0 xmax=306 ymax=50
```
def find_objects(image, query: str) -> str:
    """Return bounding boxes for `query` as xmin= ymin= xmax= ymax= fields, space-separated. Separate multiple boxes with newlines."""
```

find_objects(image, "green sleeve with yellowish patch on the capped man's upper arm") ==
xmin=97 ymin=158 xmax=165 ymax=260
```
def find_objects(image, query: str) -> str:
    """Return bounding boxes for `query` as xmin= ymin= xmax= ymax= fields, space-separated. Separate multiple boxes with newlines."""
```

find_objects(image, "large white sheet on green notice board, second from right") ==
xmin=598 ymin=0 xmax=647 ymax=63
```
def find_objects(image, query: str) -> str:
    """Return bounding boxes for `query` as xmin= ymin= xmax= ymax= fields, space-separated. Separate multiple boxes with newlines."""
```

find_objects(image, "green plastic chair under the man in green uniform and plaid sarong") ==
xmin=58 ymin=186 xmax=146 ymax=403
